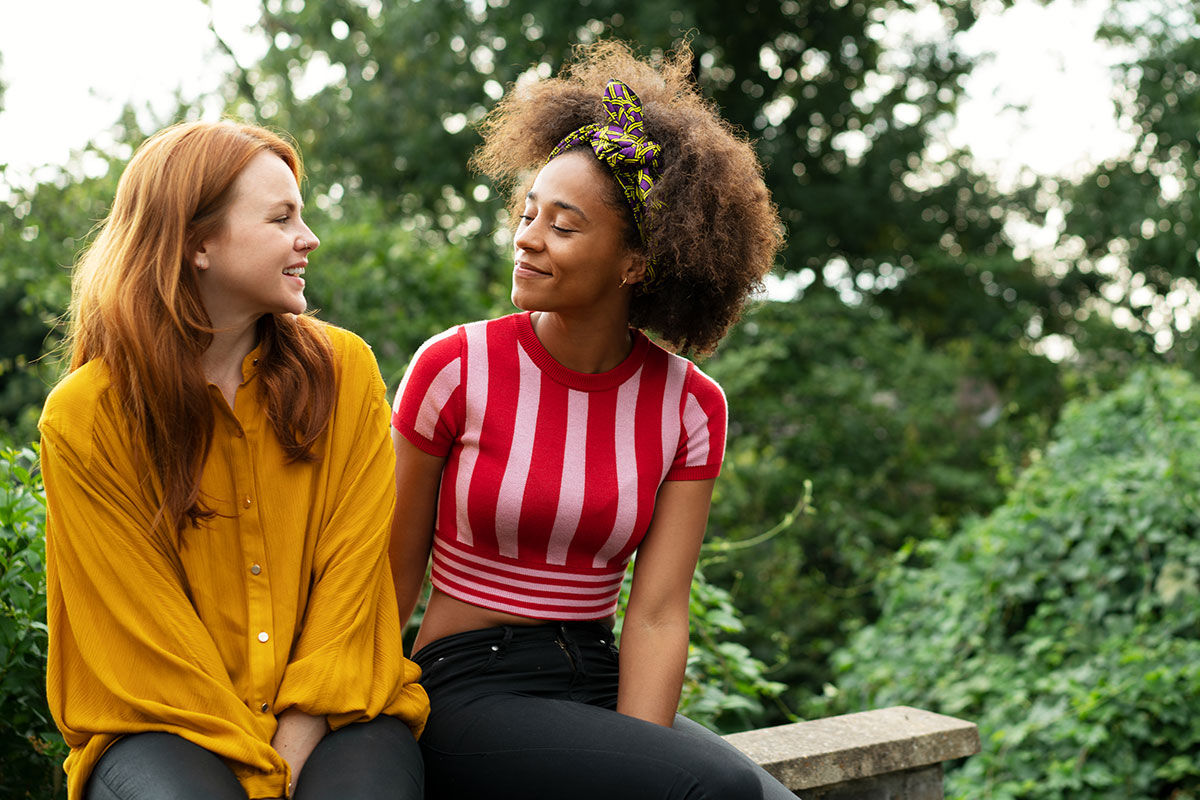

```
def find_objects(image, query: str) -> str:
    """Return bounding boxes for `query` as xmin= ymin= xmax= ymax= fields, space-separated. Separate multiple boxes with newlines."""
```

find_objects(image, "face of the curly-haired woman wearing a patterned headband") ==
xmin=512 ymin=150 xmax=643 ymax=315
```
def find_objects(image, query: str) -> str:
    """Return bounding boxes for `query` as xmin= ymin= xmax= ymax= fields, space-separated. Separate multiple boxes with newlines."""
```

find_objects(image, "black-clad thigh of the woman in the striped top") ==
xmin=420 ymin=694 xmax=763 ymax=800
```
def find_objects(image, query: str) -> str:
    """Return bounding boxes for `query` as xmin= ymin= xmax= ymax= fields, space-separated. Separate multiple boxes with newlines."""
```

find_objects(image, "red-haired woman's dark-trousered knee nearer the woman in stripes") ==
xmin=294 ymin=716 xmax=425 ymax=800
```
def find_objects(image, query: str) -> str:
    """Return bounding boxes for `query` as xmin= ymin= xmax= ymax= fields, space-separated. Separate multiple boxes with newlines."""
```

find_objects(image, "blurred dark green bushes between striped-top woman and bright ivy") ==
xmin=702 ymin=294 xmax=1060 ymax=724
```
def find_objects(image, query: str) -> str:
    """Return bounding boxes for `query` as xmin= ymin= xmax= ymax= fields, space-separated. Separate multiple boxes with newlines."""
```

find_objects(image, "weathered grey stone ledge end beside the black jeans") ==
xmin=726 ymin=705 xmax=979 ymax=800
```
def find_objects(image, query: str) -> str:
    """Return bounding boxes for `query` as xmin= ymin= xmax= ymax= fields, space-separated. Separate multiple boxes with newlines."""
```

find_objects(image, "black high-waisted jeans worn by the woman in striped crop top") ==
xmin=415 ymin=622 xmax=794 ymax=800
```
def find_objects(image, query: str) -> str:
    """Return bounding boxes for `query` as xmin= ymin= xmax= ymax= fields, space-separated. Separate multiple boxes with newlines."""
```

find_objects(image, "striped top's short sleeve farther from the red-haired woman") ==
xmin=666 ymin=365 xmax=728 ymax=481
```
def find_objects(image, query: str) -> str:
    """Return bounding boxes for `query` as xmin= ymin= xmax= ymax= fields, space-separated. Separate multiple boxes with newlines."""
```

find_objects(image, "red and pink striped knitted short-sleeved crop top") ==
xmin=392 ymin=313 xmax=726 ymax=620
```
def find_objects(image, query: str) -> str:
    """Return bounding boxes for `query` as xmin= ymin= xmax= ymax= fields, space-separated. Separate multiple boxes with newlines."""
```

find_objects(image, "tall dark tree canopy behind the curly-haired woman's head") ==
xmin=228 ymin=0 xmax=1056 ymax=355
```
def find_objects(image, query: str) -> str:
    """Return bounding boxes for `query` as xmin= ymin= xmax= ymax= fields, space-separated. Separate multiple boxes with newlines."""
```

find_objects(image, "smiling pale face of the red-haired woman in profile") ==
xmin=193 ymin=152 xmax=320 ymax=329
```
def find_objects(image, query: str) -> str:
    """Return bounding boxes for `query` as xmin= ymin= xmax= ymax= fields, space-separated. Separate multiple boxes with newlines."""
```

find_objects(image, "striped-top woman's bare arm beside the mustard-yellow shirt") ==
xmin=388 ymin=428 xmax=445 ymax=627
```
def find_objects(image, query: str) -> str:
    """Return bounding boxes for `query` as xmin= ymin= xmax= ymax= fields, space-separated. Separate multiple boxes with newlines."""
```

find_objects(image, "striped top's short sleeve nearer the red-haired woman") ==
xmin=391 ymin=327 xmax=463 ymax=457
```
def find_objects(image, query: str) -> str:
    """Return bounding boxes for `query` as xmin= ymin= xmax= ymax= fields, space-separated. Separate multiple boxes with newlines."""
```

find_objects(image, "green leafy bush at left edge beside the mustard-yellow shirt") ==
xmin=0 ymin=446 xmax=66 ymax=798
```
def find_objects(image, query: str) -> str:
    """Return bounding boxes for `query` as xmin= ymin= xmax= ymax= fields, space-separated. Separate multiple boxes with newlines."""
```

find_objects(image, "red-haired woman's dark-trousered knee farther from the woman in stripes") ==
xmin=84 ymin=733 xmax=246 ymax=800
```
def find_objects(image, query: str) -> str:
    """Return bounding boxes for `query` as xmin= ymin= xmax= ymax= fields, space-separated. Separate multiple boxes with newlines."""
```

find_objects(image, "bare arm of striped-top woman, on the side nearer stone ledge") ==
xmin=617 ymin=479 xmax=715 ymax=726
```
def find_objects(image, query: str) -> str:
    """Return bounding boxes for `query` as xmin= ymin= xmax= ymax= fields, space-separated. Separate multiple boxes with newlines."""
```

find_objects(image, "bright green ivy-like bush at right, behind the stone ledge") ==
xmin=811 ymin=368 xmax=1200 ymax=800
